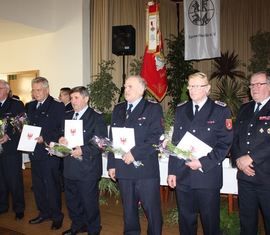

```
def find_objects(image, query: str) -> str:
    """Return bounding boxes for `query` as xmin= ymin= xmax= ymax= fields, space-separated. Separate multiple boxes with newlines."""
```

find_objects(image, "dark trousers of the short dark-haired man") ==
xmin=65 ymin=178 xmax=101 ymax=234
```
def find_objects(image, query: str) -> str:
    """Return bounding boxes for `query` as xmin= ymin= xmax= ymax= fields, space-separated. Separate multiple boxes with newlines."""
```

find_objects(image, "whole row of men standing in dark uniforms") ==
xmin=0 ymin=72 xmax=270 ymax=235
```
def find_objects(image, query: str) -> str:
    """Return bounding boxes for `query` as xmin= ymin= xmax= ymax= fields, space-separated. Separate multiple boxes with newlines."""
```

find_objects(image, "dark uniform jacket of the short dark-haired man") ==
xmin=64 ymin=107 xmax=107 ymax=181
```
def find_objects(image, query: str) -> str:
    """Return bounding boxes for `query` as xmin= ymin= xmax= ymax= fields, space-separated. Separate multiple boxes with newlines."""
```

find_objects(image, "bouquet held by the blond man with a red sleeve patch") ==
xmin=154 ymin=135 xmax=192 ymax=161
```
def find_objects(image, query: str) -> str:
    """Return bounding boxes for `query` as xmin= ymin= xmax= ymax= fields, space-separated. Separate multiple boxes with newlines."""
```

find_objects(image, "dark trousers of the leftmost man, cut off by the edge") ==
xmin=0 ymin=152 xmax=25 ymax=213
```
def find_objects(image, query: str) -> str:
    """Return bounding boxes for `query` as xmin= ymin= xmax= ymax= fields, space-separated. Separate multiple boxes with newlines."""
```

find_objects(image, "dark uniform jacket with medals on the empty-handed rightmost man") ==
xmin=232 ymin=98 xmax=270 ymax=184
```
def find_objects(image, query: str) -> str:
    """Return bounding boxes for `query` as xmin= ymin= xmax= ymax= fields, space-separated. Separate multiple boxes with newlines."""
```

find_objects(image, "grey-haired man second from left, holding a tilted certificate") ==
xmin=27 ymin=77 xmax=65 ymax=230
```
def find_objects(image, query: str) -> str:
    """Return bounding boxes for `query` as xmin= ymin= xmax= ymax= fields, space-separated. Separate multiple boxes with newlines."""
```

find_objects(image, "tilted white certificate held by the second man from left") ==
xmin=17 ymin=125 xmax=41 ymax=152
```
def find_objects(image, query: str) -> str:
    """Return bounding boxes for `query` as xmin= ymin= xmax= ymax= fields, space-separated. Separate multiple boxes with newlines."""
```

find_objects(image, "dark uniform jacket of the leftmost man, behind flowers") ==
xmin=0 ymin=97 xmax=25 ymax=154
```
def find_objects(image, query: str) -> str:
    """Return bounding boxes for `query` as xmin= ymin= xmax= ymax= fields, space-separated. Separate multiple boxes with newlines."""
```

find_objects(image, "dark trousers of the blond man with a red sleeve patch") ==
xmin=176 ymin=185 xmax=220 ymax=235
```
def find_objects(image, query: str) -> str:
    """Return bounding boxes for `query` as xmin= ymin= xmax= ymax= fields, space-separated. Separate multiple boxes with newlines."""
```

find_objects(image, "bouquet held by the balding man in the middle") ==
xmin=90 ymin=135 xmax=143 ymax=168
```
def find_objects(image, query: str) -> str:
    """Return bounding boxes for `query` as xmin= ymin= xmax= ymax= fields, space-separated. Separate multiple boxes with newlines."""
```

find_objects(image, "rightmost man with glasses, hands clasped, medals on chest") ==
xmin=232 ymin=72 xmax=270 ymax=235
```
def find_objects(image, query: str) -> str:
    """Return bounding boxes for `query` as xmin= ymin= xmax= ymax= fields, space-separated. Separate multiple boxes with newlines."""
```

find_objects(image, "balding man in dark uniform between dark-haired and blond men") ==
xmin=107 ymin=76 xmax=163 ymax=235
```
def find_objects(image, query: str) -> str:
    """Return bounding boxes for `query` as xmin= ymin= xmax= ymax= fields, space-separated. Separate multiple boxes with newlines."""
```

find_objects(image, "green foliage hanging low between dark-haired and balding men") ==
xmin=99 ymin=178 xmax=120 ymax=205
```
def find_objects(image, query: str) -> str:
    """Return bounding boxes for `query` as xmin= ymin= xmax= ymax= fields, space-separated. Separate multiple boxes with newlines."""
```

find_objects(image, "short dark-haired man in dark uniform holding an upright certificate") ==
xmin=59 ymin=86 xmax=107 ymax=235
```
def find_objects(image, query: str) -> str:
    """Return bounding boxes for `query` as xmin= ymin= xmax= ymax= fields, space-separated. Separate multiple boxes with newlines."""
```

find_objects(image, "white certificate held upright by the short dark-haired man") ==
xmin=65 ymin=120 xmax=84 ymax=148
